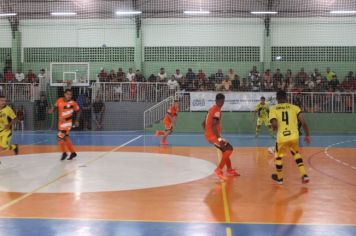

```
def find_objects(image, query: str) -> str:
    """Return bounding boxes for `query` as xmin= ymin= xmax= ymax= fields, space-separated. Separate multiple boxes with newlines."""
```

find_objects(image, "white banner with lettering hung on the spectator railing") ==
xmin=190 ymin=92 xmax=277 ymax=111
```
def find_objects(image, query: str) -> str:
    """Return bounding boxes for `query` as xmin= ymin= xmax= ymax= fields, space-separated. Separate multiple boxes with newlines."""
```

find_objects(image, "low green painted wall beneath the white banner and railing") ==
xmin=148 ymin=112 xmax=356 ymax=134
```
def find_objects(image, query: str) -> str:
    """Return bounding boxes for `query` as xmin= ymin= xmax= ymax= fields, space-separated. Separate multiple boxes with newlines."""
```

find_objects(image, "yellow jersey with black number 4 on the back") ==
xmin=269 ymin=103 xmax=301 ymax=143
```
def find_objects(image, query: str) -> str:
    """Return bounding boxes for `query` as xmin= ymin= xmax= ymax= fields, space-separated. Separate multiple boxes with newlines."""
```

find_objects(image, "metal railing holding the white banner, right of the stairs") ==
xmin=176 ymin=92 xmax=356 ymax=113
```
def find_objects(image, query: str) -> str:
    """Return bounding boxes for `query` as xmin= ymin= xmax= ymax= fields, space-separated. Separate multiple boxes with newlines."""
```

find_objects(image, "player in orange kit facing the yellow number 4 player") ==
xmin=202 ymin=93 xmax=240 ymax=179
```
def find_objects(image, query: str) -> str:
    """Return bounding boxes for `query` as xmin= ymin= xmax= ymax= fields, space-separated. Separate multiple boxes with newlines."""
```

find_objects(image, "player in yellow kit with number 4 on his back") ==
xmin=269 ymin=91 xmax=310 ymax=184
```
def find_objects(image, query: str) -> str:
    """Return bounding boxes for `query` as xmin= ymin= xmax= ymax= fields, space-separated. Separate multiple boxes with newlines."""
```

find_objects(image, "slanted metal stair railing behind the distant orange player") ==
xmin=143 ymin=96 xmax=174 ymax=129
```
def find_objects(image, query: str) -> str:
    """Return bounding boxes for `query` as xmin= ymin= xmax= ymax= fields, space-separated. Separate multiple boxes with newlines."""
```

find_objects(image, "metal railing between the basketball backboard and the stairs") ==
xmin=92 ymin=82 xmax=177 ymax=102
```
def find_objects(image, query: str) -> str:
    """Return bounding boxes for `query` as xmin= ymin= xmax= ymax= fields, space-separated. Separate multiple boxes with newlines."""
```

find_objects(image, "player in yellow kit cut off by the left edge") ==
xmin=0 ymin=96 xmax=19 ymax=155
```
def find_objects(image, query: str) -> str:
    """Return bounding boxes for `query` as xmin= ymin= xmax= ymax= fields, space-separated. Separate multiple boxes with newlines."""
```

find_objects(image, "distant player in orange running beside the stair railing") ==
xmin=156 ymin=100 xmax=179 ymax=145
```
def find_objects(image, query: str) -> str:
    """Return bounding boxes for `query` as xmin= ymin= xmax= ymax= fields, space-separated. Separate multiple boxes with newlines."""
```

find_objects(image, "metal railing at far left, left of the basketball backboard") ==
xmin=0 ymin=83 xmax=40 ymax=102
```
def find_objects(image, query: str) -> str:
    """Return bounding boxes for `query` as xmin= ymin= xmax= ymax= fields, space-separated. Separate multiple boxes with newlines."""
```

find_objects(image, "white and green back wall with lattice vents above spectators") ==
xmin=0 ymin=17 xmax=356 ymax=79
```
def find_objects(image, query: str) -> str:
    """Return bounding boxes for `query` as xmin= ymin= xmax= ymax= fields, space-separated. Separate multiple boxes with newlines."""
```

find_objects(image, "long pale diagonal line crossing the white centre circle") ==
xmin=0 ymin=135 xmax=143 ymax=211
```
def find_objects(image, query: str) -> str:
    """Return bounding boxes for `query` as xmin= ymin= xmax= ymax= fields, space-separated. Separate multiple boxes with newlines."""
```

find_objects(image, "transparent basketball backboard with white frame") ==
xmin=50 ymin=62 xmax=90 ymax=86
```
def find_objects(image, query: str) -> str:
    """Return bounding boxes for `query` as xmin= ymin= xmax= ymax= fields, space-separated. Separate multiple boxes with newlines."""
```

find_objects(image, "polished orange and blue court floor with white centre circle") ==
xmin=0 ymin=132 xmax=356 ymax=236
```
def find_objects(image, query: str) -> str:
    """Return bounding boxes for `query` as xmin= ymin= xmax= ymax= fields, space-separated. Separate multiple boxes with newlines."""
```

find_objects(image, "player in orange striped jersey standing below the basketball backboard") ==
xmin=49 ymin=89 xmax=80 ymax=161
